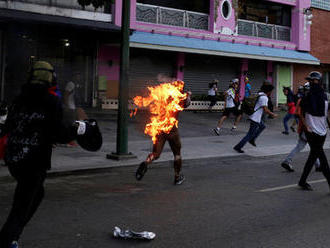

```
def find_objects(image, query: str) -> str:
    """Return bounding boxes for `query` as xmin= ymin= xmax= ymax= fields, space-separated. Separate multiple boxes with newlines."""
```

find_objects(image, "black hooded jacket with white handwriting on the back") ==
xmin=2 ymin=84 xmax=76 ymax=169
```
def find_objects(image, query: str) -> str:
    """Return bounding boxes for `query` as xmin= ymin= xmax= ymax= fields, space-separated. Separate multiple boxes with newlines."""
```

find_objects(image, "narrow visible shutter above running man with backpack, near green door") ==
xmin=247 ymin=60 xmax=267 ymax=93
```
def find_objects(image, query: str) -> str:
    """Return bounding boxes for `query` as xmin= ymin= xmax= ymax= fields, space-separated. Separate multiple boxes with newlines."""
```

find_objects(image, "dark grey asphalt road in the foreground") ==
xmin=0 ymin=151 xmax=330 ymax=248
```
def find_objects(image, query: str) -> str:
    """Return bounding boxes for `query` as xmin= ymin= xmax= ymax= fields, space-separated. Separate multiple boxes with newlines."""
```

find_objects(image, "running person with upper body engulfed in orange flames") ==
xmin=134 ymin=74 xmax=191 ymax=185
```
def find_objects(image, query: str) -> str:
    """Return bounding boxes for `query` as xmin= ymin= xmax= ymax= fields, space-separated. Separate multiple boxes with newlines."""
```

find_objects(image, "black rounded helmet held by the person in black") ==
xmin=77 ymin=119 xmax=102 ymax=152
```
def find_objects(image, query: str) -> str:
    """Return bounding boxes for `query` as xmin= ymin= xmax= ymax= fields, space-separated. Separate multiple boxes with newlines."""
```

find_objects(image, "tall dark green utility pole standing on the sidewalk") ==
xmin=107 ymin=0 xmax=136 ymax=160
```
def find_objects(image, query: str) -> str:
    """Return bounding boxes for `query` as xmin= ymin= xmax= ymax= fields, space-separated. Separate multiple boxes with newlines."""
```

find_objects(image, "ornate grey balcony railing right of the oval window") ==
xmin=238 ymin=19 xmax=291 ymax=41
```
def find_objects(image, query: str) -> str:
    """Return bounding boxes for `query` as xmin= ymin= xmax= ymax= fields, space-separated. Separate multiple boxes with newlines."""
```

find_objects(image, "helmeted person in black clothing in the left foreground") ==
xmin=0 ymin=61 xmax=83 ymax=248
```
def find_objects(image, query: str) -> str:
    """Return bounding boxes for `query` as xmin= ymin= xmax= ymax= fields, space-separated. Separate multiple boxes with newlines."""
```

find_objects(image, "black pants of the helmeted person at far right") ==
xmin=299 ymin=132 xmax=330 ymax=186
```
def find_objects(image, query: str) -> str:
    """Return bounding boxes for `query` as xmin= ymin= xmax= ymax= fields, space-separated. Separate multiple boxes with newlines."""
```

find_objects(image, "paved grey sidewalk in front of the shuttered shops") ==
xmin=0 ymin=111 xmax=330 ymax=177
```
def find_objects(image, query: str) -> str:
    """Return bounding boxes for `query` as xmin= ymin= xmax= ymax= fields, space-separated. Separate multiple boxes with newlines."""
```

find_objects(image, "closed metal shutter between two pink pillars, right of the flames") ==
xmin=184 ymin=54 xmax=240 ymax=95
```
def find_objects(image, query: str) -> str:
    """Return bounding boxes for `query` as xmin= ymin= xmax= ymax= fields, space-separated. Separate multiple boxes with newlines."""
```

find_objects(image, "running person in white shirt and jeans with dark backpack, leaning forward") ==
xmin=234 ymin=84 xmax=277 ymax=153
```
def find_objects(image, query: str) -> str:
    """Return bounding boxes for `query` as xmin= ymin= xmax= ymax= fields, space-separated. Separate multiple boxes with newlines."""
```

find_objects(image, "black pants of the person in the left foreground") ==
xmin=0 ymin=167 xmax=46 ymax=248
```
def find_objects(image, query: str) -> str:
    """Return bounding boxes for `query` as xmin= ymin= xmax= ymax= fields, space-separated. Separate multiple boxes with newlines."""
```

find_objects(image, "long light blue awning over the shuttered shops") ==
xmin=130 ymin=31 xmax=320 ymax=65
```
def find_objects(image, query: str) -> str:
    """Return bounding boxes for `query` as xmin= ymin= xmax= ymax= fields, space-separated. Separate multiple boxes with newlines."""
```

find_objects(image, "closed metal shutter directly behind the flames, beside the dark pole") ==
xmin=129 ymin=49 xmax=176 ymax=97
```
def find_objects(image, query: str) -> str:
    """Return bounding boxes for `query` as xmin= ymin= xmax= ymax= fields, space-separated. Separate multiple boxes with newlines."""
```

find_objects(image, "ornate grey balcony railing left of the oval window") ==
xmin=136 ymin=3 xmax=209 ymax=30
